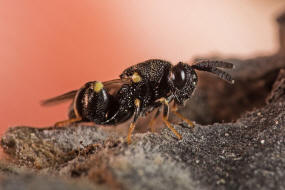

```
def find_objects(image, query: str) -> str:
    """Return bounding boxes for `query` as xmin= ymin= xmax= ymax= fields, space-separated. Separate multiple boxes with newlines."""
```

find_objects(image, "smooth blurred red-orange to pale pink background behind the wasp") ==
xmin=0 ymin=0 xmax=285 ymax=134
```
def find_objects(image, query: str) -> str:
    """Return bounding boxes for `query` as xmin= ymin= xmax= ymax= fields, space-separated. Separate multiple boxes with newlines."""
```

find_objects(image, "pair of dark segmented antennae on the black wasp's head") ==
xmin=191 ymin=60 xmax=235 ymax=84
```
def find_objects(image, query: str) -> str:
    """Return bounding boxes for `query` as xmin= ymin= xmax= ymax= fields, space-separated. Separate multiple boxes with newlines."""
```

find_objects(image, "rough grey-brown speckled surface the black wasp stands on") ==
xmin=0 ymin=10 xmax=285 ymax=190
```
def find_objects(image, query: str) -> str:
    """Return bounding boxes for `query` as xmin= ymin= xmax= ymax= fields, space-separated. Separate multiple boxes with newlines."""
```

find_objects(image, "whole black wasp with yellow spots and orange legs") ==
xmin=42 ymin=59 xmax=234 ymax=143
